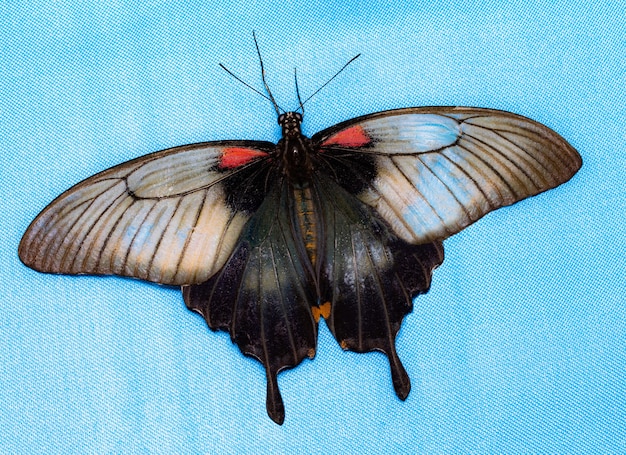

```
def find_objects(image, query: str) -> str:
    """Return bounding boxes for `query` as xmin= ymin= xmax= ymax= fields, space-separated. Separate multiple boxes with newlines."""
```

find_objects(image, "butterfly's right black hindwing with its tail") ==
xmin=317 ymin=175 xmax=443 ymax=400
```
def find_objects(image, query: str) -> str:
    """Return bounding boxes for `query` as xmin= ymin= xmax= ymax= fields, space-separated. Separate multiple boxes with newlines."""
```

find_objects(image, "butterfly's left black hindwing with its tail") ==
xmin=183 ymin=180 xmax=317 ymax=424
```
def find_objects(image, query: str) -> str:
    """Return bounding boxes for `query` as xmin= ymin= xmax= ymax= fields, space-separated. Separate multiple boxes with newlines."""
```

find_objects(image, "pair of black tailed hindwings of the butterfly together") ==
xmin=183 ymin=175 xmax=443 ymax=423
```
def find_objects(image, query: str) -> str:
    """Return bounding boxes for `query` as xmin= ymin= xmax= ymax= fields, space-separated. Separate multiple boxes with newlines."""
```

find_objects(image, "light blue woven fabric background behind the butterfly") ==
xmin=0 ymin=0 xmax=626 ymax=454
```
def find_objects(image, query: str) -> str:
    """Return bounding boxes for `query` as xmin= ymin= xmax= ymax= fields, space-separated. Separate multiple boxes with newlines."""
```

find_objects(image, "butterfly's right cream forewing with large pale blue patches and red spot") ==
xmin=312 ymin=107 xmax=582 ymax=244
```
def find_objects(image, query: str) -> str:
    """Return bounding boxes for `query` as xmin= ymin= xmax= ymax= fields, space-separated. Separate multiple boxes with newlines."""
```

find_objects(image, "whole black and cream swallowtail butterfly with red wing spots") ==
xmin=19 ymin=39 xmax=582 ymax=424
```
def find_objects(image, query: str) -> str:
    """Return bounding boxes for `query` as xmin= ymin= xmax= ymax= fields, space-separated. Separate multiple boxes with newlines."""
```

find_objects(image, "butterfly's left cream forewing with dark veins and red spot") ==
xmin=19 ymin=141 xmax=275 ymax=285
